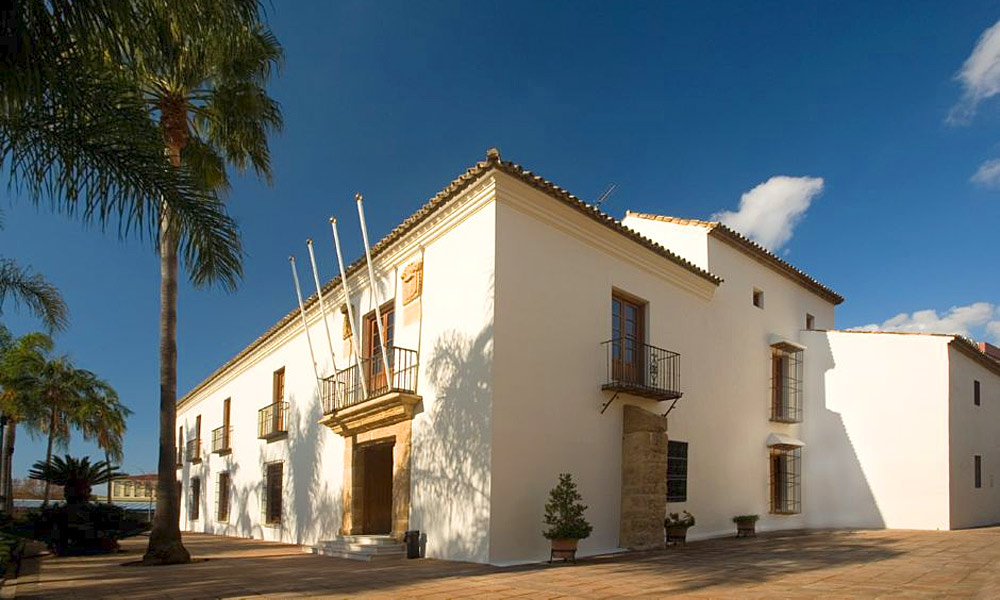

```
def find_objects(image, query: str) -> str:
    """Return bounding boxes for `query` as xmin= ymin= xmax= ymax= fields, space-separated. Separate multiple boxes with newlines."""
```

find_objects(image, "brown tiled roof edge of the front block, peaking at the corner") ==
xmin=178 ymin=148 xmax=722 ymax=404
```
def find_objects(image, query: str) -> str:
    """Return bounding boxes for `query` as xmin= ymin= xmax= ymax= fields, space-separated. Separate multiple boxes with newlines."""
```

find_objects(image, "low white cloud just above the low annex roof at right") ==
xmin=853 ymin=302 xmax=1000 ymax=342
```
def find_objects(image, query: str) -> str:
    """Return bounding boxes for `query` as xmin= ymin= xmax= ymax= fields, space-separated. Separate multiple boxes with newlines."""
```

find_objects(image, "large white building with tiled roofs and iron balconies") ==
xmin=178 ymin=151 xmax=1000 ymax=564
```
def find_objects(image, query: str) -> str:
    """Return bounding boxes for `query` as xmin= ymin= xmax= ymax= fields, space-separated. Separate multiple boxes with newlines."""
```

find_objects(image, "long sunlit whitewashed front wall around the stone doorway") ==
xmin=178 ymin=181 xmax=496 ymax=562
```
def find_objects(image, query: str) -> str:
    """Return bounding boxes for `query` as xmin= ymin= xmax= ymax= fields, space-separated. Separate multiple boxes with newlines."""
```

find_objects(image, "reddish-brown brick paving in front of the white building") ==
xmin=3 ymin=527 xmax=1000 ymax=600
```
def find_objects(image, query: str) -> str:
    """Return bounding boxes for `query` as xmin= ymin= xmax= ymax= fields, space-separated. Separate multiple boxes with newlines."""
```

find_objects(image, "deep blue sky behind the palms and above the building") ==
xmin=0 ymin=1 xmax=1000 ymax=475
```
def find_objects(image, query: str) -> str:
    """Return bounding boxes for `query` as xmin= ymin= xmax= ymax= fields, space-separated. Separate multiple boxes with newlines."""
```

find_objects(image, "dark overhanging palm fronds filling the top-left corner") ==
xmin=0 ymin=0 xmax=248 ymax=276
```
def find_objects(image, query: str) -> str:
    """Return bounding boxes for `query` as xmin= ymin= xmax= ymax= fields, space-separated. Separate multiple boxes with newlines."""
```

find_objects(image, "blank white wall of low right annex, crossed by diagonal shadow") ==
xmin=803 ymin=331 xmax=948 ymax=529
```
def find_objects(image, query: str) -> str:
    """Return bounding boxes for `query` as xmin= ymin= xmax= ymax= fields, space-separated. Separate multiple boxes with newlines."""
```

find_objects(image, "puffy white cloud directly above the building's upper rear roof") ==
xmin=712 ymin=175 xmax=823 ymax=250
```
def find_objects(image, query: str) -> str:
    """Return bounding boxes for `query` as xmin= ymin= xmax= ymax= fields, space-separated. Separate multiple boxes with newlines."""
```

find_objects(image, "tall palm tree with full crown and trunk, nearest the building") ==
xmin=131 ymin=5 xmax=282 ymax=564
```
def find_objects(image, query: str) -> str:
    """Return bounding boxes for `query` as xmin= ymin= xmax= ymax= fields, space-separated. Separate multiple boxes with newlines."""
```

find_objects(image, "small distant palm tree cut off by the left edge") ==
xmin=0 ymin=327 xmax=53 ymax=514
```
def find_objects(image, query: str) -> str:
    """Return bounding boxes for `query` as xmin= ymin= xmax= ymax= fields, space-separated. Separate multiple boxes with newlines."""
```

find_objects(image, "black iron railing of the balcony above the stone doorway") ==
xmin=322 ymin=346 xmax=418 ymax=414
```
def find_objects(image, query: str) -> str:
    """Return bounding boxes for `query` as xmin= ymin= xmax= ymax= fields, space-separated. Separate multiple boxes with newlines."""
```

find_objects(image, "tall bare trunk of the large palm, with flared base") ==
xmin=143 ymin=145 xmax=191 ymax=564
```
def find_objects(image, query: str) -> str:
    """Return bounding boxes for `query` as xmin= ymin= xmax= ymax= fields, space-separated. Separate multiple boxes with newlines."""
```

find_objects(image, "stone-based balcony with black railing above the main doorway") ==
xmin=320 ymin=346 xmax=421 ymax=435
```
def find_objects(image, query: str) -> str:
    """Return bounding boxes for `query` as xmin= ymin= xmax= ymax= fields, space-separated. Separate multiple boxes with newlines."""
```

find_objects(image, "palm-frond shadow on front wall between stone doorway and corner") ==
xmin=411 ymin=324 xmax=493 ymax=560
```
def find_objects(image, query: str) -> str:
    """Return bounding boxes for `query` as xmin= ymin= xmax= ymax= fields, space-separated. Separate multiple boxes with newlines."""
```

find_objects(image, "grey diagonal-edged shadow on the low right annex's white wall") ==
xmin=802 ymin=334 xmax=885 ymax=528
